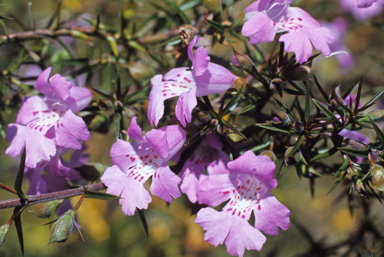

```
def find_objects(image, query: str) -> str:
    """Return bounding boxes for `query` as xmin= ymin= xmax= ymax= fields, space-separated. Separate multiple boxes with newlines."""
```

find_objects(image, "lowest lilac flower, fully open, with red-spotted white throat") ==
xmin=195 ymin=151 xmax=290 ymax=256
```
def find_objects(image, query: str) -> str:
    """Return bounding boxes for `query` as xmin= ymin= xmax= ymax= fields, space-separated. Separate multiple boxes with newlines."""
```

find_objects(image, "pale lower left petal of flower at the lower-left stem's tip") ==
xmin=100 ymin=165 xmax=152 ymax=215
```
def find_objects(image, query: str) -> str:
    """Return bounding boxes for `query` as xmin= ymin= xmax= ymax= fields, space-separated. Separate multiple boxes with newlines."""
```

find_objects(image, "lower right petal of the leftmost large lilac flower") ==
xmin=56 ymin=110 xmax=90 ymax=149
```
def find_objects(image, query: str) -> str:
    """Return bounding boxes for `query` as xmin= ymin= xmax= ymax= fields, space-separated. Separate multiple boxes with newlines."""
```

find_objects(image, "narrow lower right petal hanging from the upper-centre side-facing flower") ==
xmin=175 ymin=87 xmax=197 ymax=127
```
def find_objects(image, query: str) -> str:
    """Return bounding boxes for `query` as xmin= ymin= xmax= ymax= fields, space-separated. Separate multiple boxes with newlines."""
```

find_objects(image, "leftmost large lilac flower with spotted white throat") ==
xmin=5 ymin=68 xmax=91 ymax=168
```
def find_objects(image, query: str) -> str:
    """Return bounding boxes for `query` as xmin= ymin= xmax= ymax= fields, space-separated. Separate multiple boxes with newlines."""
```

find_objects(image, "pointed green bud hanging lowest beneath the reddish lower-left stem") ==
xmin=49 ymin=210 xmax=76 ymax=244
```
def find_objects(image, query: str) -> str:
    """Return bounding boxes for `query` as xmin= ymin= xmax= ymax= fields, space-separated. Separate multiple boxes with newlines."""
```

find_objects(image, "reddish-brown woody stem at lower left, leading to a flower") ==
xmin=0 ymin=182 xmax=107 ymax=210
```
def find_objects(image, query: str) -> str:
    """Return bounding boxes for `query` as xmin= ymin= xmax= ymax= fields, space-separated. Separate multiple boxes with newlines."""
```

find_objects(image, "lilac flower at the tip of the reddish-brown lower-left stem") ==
xmin=101 ymin=117 xmax=185 ymax=215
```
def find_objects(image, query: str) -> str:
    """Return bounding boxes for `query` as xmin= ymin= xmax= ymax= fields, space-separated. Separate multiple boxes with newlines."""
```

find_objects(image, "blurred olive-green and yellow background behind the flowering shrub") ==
xmin=0 ymin=0 xmax=384 ymax=257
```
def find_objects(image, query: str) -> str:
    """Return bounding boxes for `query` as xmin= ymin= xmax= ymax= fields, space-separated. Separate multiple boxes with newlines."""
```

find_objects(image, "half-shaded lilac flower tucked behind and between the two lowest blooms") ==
xmin=180 ymin=133 xmax=230 ymax=203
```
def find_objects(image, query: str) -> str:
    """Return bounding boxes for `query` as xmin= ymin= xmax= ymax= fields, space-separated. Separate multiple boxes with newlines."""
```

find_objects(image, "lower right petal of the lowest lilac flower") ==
xmin=253 ymin=193 xmax=291 ymax=236
